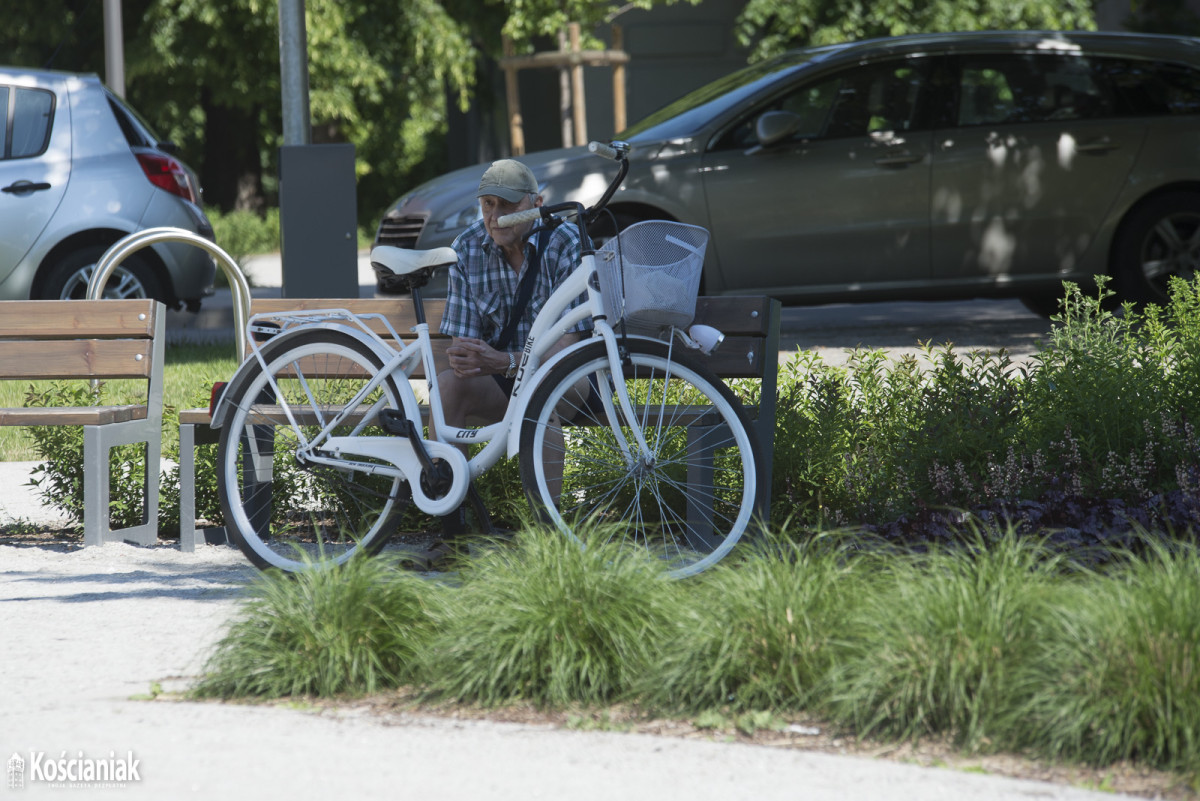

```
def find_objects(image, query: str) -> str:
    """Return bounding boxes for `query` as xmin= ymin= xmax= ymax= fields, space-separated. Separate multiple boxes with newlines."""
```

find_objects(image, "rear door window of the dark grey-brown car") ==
xmin=958 ymin=54 xmax=1114 ymax=126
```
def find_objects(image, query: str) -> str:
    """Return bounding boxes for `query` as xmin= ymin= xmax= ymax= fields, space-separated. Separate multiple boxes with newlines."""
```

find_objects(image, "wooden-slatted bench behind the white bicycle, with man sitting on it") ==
xmin=179 ymin=296 xmax=780 ymax=550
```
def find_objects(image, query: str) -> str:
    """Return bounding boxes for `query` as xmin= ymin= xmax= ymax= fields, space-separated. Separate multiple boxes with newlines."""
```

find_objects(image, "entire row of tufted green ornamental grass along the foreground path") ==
xmin=193 ymin=530 xmax=1200 ymax=783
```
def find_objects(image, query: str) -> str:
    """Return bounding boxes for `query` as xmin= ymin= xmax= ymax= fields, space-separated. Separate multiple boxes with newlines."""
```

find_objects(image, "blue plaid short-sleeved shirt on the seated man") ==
xmin=440 ymin=219 xmax=589 ymax=350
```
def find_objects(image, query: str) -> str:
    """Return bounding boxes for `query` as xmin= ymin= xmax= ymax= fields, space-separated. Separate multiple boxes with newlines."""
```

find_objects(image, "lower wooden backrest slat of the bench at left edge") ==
xmin=0 ymin=339 xmax=154 ymax=380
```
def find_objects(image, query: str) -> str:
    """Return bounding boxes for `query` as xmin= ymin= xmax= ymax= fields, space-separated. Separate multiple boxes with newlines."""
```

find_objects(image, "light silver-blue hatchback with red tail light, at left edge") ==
xmin=0 ymin=67 xmax=216 ymax=309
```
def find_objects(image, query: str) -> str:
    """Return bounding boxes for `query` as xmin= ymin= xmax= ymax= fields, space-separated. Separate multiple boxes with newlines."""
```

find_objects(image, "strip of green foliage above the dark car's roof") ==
xmin=738 ymin=0 xmax=1096 ymax=61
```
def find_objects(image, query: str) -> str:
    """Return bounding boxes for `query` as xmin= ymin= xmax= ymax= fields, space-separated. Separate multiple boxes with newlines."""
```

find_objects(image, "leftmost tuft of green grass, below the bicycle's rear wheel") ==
xmin=193 ymin=559 xmax=439 ymax=698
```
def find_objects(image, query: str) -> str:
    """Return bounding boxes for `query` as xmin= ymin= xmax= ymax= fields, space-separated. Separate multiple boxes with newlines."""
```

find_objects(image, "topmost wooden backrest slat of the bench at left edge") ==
xmin=0 ymin=300 xmax=158 ymax=339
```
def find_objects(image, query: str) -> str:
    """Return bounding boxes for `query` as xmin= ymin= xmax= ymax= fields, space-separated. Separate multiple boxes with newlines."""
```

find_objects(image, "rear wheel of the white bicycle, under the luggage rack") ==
xmin=217 ymin=330 xmax=410 ymax=572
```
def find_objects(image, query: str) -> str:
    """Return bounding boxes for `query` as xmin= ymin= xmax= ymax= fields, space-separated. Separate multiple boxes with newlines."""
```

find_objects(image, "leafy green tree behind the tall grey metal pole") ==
xmin=128 ymin=0 xmax=473 ymax=210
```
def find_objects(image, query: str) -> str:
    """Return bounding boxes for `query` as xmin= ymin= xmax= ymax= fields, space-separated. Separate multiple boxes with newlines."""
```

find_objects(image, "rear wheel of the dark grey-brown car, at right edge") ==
xmin=1112 ymin=192 xmax=1200 ymax=303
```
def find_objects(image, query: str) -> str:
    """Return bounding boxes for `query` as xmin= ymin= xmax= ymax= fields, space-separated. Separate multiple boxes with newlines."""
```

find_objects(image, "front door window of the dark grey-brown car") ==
xmin=716 ymin=61 xmax=925 ymax=149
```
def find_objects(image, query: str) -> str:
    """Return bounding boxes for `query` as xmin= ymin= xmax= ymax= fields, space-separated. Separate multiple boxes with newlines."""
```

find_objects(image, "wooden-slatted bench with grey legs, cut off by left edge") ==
xmin=0 ymin=300 xmax=166 ymax=546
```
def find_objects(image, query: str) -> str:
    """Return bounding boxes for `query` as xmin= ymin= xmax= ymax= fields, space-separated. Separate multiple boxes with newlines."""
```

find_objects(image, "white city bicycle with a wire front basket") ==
xmin=212 ymin=143 xmax=764 ymax=576
